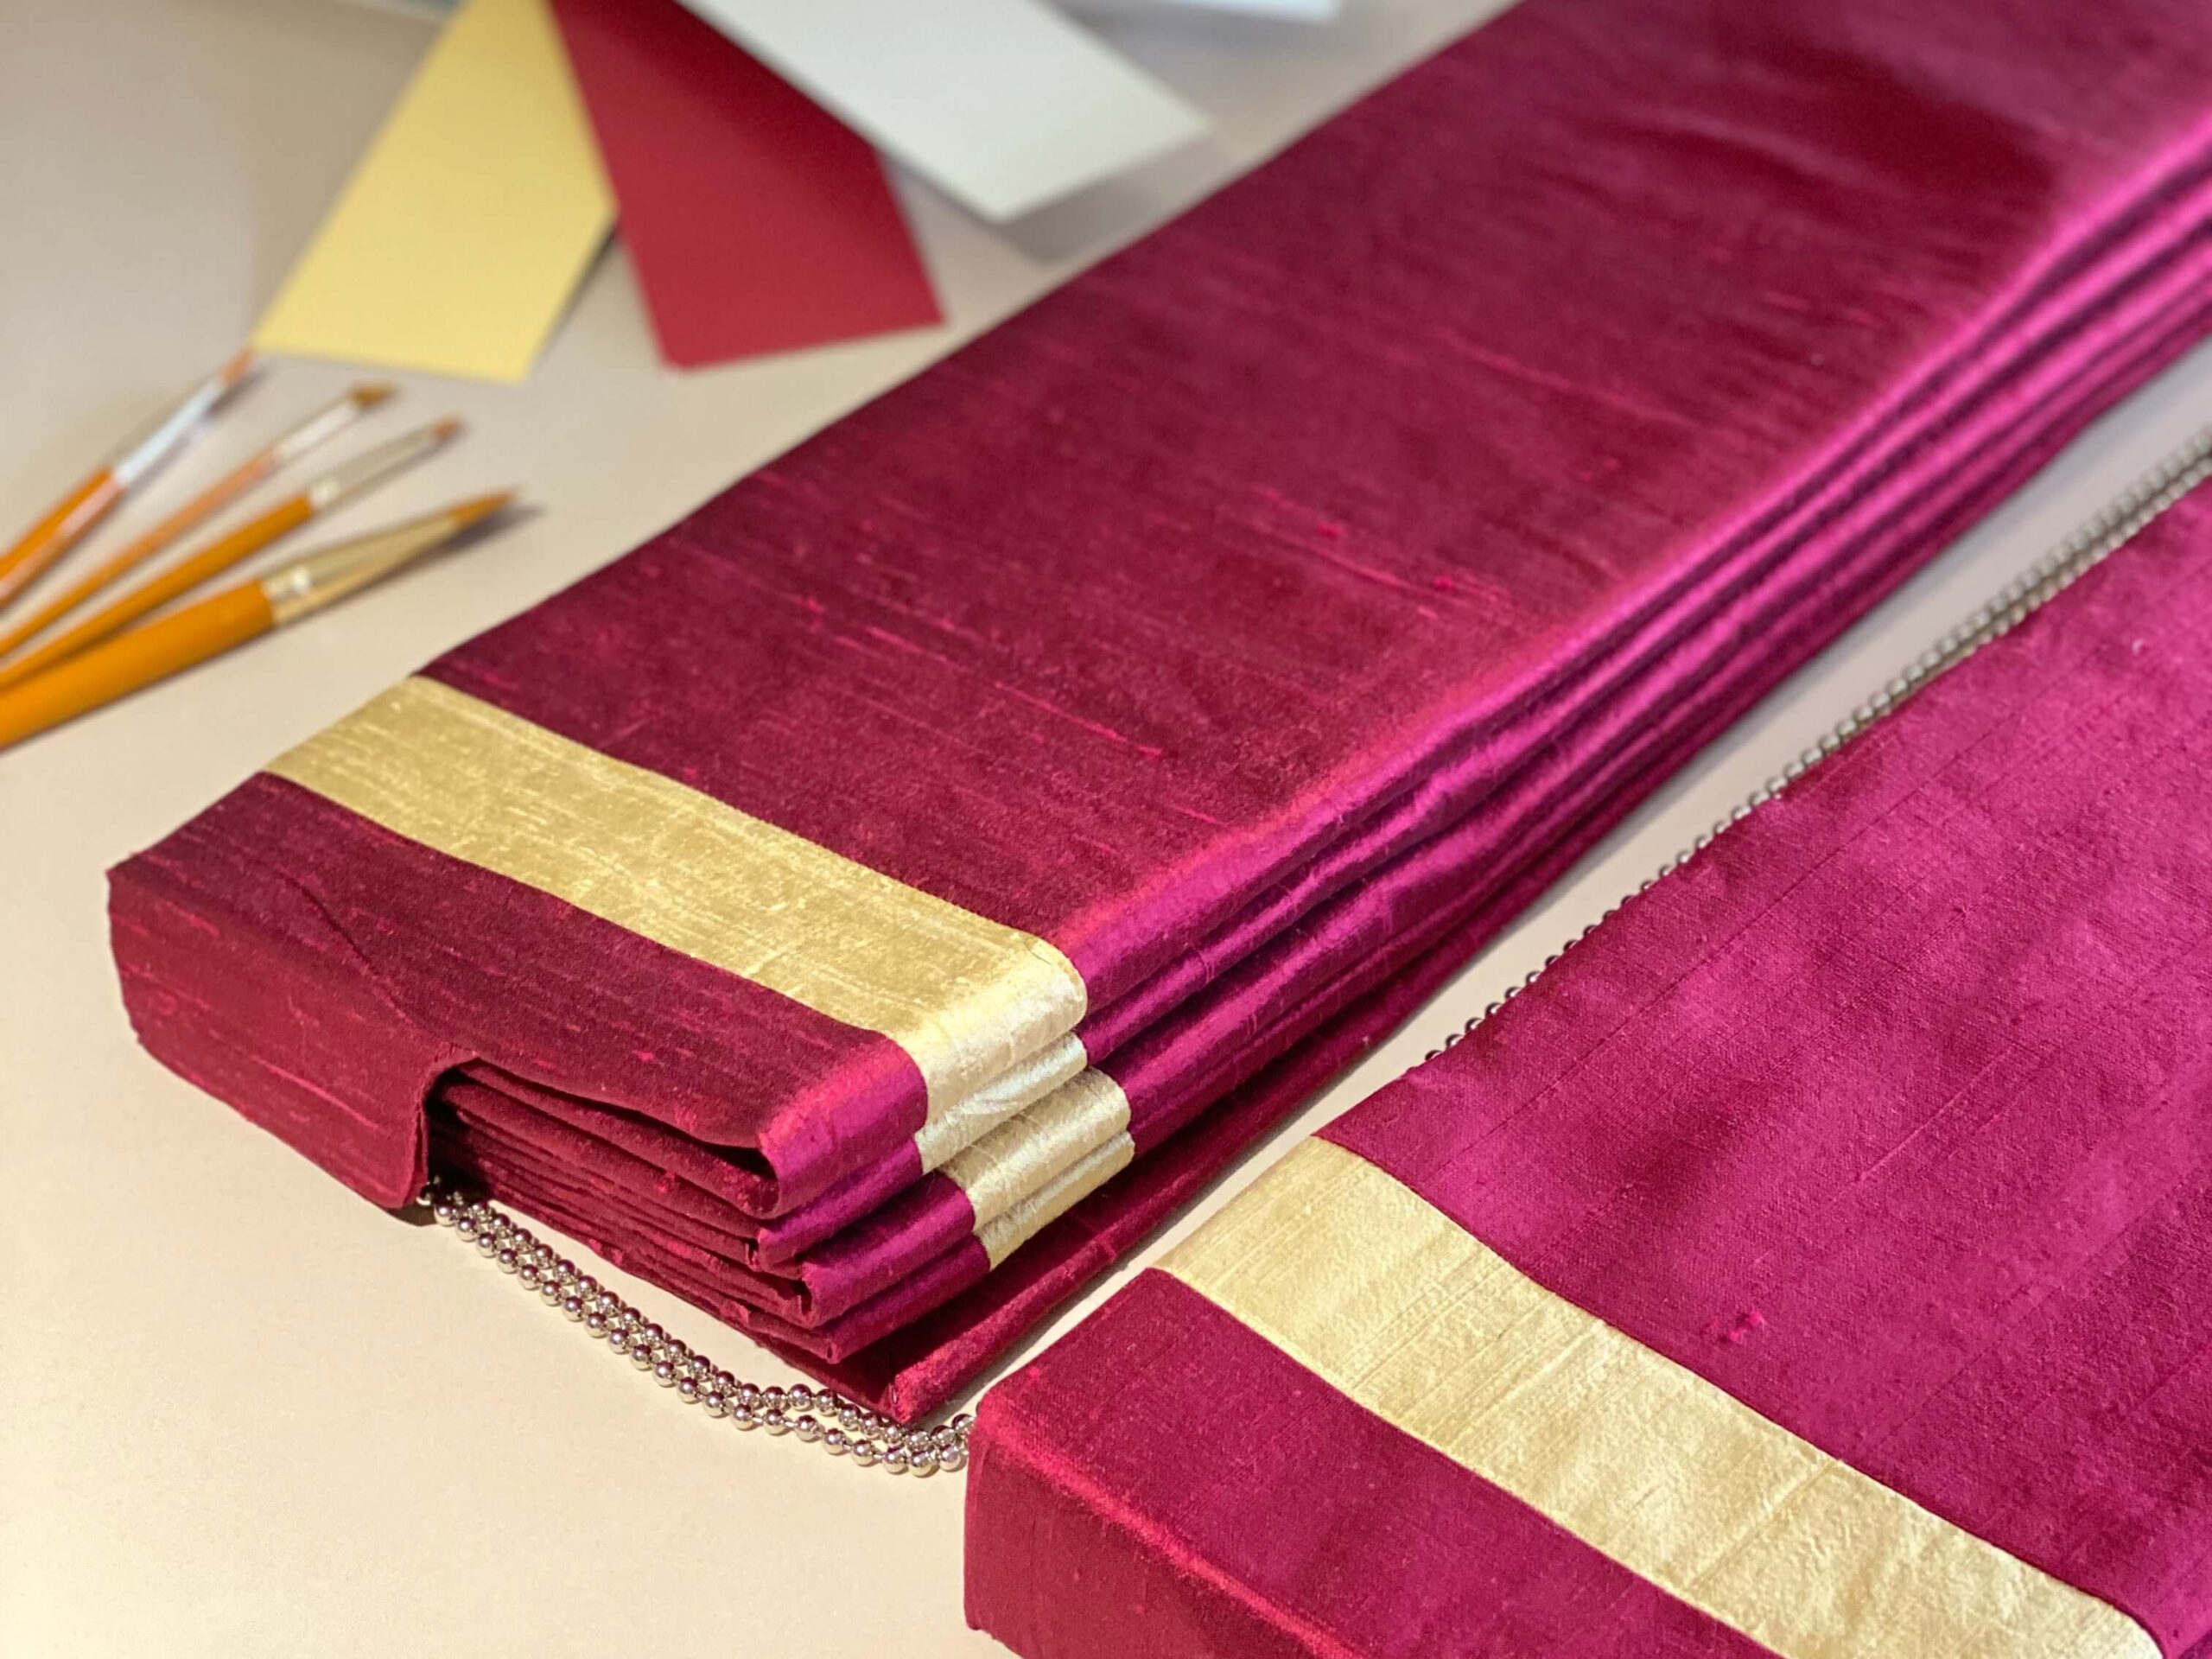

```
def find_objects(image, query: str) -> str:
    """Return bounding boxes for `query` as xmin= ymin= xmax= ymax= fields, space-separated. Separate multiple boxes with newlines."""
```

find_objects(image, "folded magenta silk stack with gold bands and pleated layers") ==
xmin=113 ymin=0 xmax=2212 ymax=1415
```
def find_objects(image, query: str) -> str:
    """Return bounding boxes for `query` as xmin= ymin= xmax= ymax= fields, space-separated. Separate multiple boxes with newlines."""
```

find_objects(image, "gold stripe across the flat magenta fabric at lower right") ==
xmin=1161 ymin=1139 xmax=2159 ymax=1659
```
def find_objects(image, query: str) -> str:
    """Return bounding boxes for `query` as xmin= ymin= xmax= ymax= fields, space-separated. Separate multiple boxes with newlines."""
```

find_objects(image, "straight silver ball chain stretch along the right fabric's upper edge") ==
xmin=1422 ymin=427 xmax=2212 ymax=1059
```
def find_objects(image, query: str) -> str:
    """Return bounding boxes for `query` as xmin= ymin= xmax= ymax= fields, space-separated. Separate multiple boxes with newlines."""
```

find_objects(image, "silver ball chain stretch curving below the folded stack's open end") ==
xmin=423 ymin=1181 xmax=976 ymax=1478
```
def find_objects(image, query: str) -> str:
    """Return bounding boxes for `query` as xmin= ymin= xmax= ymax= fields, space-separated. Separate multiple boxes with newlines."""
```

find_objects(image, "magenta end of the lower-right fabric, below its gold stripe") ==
xmin=967 ymin=1272 xmax=1767 ymax=1659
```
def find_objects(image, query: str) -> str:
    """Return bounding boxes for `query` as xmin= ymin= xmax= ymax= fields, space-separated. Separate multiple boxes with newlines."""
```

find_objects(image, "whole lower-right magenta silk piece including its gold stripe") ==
xmin=967 ymin=489 xmax=2212 ymax=1659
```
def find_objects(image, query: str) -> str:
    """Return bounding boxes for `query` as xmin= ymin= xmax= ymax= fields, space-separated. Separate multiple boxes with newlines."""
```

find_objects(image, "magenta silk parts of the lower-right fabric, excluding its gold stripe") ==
xmin=969 ymin=489 xmax=2212 ymax=1659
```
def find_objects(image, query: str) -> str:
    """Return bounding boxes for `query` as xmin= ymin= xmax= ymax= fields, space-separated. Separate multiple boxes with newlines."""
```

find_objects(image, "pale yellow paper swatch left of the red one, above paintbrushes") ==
xmin=254 ymin=0 xmax=615 ymax=380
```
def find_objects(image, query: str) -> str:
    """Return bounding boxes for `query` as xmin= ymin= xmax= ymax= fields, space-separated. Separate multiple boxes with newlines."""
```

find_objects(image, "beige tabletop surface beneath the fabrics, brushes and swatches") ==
xmin=0 ymin=0 xmax=2212 ymax=1659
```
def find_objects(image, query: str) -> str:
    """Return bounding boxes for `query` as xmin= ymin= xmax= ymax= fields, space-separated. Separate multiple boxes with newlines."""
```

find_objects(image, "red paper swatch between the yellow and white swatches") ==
xmin=553 ymin=0 xmax=938 ymax=367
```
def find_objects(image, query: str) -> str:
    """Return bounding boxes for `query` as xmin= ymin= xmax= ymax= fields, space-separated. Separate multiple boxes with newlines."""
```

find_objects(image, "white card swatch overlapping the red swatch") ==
xmin=683 ymin=0 xmax=1205 ymax=219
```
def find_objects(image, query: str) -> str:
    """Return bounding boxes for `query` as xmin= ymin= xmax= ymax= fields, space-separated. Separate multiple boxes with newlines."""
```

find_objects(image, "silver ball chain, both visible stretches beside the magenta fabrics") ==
xmin=423 ymin=429 xmax=2212 ymax=1476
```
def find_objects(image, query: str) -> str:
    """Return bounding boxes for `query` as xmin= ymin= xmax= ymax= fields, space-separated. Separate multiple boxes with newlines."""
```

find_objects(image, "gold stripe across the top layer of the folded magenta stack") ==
xmin=268 ymin=679 xmax=1084 ymax=1117
